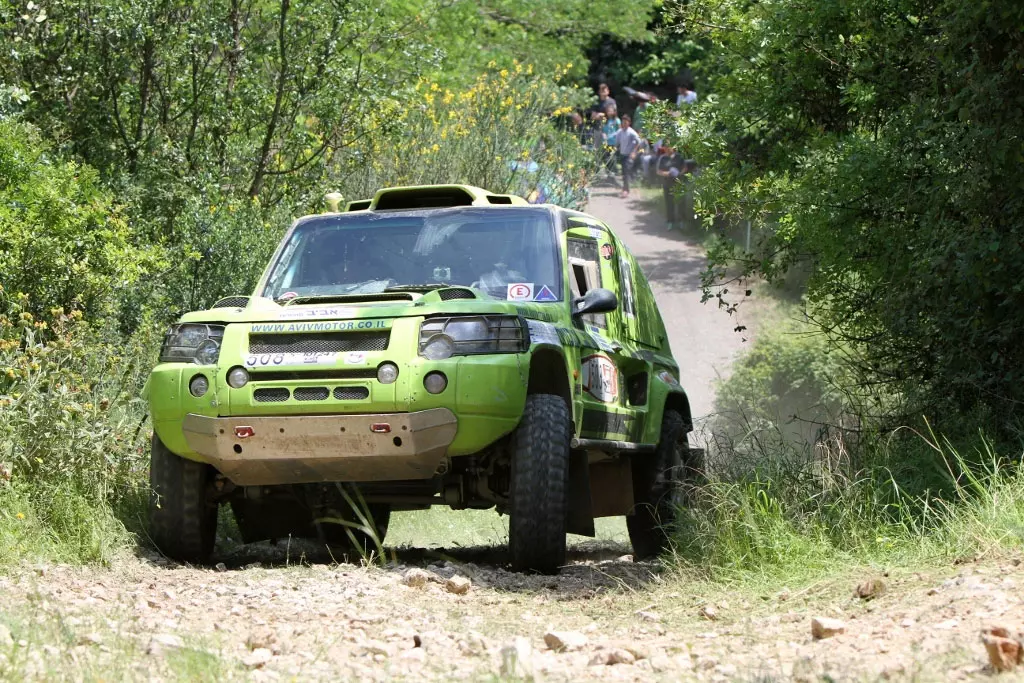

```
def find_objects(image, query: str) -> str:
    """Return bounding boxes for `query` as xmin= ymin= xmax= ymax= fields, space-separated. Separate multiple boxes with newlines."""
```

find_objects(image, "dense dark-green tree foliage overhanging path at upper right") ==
xmin=659 ymin=0 xmax=1024 ymax=426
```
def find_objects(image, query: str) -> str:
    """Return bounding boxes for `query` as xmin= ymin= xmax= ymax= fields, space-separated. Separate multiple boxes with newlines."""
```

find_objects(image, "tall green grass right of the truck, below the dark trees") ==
xmin=673 ymin=423 xmax=1024 ymax=582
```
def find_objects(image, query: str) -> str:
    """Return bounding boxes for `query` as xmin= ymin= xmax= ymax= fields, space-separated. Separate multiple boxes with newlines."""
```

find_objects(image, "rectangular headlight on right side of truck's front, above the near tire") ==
xmin=420 ymin=315 xmax=529 ymax=360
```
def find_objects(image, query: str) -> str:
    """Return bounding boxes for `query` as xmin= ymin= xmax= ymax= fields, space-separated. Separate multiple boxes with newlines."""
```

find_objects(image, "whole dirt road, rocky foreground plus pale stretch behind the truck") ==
xmin=0 ymin=189 xmax=1011 ymax=681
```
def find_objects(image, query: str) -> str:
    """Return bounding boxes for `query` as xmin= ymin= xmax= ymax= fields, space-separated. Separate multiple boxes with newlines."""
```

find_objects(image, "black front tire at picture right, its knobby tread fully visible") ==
xmin=509 ymin=394 xmax=572 ymax=573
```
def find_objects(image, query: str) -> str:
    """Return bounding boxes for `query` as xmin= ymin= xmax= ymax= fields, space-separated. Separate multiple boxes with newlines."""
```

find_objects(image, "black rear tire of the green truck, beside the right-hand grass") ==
xmin=626 ymin=409 xmax=692 ymax=559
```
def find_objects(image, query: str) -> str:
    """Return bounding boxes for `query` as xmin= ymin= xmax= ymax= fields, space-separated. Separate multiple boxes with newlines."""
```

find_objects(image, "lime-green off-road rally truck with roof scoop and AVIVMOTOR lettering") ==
xmin=144 ymin=185 xmax=699 ymax=572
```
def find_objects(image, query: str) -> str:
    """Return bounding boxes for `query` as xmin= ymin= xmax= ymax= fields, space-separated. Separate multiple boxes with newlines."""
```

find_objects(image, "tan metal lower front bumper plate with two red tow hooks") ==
xmin=182 ymin=408 xmax=458 ymax=486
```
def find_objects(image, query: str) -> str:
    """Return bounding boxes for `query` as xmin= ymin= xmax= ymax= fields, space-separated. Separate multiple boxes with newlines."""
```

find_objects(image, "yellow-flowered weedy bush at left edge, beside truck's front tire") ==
xmin=0 ymin=289 xmax=155 ymax=563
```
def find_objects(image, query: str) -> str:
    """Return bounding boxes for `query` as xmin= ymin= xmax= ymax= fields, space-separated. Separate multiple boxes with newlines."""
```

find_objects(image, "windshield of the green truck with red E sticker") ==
xmin=262 ymin=207 xmax=562 ymax=301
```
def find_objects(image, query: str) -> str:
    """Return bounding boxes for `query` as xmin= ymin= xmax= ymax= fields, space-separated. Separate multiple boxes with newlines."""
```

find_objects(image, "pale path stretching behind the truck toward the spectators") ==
xmin=587 ymin=185 xmax=742 ymax=426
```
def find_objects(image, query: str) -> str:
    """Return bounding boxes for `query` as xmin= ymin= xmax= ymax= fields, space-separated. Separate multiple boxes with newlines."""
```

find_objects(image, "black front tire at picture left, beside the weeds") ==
xmin=150 ymin=434 xmax=217 ymax=564
